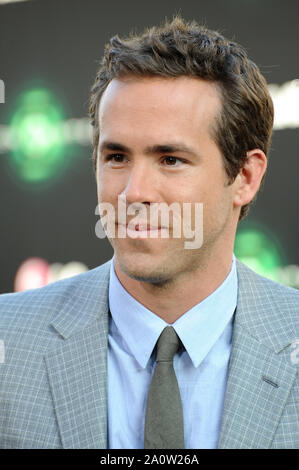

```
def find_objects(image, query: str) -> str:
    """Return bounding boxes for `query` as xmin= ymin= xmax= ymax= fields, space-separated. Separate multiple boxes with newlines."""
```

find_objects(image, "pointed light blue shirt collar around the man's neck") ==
xmin=109 ymin=256 xmax=238 ymax=368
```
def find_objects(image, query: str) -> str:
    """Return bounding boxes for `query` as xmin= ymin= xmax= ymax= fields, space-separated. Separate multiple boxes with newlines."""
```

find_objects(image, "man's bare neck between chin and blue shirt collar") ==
xmin=114 ymin=251 xmax=232 ymax=324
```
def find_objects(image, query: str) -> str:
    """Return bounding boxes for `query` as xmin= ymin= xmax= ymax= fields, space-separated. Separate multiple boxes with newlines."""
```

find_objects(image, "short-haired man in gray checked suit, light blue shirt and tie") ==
xmin=0 ymin=17 xmax=299 ymax=448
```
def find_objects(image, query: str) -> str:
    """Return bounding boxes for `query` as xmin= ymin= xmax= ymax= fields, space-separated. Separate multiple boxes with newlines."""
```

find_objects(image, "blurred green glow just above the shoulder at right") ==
xmin=234 ymin=228 xmax=283 ymax=281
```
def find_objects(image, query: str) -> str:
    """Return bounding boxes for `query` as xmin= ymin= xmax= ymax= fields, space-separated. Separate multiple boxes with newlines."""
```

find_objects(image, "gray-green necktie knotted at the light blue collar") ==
xmin=144 ymin=326 xmax=184 ymax=449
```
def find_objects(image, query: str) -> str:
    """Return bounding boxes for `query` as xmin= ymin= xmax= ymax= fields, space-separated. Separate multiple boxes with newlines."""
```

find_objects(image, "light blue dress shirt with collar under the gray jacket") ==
xmin=108 ymin=257 xmax=238 ymax=449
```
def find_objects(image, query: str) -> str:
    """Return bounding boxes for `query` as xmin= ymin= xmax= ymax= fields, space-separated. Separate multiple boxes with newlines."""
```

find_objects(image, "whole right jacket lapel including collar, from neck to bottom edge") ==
xmin=218 ymin=263 xmax=296 ymax=449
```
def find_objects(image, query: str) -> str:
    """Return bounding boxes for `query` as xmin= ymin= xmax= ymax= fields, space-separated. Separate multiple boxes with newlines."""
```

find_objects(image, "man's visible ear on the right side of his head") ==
xmin=233 ymin=149 xmax=267 ymax=207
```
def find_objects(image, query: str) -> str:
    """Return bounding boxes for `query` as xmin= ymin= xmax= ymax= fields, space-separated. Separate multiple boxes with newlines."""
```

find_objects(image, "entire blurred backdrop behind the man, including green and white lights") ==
xmin=0 ymin=0 xmax=299 ymax=293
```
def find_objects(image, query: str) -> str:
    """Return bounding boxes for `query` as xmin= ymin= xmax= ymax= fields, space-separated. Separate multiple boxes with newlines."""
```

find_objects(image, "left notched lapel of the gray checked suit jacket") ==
xmin=45 ymin=264 xmax=109 ymax=449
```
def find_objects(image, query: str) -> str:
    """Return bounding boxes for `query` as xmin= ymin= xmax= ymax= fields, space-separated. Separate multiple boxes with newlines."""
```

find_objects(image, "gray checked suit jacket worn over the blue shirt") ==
xmin=0 ymin=262 xmax=299 ymax=449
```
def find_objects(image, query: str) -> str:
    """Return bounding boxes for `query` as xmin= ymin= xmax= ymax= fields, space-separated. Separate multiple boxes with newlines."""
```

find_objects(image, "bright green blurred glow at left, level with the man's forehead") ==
xmin=11 ymin=88 xmax=65 ymax=182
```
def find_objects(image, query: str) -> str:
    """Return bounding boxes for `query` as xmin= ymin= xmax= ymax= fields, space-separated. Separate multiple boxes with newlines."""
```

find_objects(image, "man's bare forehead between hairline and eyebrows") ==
xmin=99 ymin=77 xmax=221 ymax=140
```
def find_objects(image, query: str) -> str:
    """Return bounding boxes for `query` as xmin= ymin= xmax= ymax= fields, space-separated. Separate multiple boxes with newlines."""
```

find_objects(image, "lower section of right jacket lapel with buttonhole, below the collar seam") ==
xmin=218 ymin=325 xmax=296 ymax=449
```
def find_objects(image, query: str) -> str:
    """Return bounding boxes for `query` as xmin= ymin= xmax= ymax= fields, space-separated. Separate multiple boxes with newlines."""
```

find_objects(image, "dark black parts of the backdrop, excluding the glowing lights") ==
xmin=0 ymin=0 xmax=299 ymax=292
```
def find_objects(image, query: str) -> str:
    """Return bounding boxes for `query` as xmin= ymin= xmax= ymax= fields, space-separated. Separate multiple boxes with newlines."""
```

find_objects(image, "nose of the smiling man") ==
xmin=121 ymin=162 xmax=158 ymax=204
